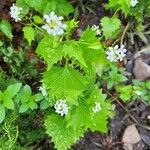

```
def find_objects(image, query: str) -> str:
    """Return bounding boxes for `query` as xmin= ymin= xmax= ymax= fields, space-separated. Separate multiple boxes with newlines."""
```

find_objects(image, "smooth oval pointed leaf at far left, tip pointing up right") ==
xmin=3 ymin=83 xmax=22 ymax=98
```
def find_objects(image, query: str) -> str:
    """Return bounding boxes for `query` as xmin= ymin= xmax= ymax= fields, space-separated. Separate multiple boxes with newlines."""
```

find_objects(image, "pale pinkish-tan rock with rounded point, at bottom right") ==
xmin=122 ymin=125 xmax=141 ymax=150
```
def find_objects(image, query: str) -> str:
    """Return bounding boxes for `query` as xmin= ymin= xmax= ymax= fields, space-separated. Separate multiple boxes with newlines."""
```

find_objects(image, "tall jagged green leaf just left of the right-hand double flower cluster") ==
xmin=79 ymin=28 xmax=106 ymax=78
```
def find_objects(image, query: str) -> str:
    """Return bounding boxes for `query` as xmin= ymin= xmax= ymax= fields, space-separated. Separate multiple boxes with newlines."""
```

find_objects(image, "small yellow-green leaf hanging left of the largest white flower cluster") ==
xmin=23 ymin=26 xmax=35 ymax=45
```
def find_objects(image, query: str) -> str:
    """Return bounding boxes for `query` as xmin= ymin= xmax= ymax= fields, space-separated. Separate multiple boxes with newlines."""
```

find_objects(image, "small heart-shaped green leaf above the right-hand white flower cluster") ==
xmin=101 ymin=16 xmax=121 ymax=39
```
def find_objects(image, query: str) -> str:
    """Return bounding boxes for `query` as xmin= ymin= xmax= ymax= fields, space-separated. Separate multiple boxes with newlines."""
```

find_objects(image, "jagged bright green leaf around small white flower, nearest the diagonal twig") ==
xmin=87 ymin=87 xmax=114 ymax=133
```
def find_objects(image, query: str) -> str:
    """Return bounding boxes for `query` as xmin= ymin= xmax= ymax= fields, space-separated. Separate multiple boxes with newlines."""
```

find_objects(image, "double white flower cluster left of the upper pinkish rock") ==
xmin=106 ymin=45 xmax=127 ymax=62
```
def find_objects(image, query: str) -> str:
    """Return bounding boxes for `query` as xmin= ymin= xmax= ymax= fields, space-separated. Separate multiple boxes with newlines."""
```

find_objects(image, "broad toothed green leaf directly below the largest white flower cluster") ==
xmin=36 ymin=36 xmax=64 ymax=69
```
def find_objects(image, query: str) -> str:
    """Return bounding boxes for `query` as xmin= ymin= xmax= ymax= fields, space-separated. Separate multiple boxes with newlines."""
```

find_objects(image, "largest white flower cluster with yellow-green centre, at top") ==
xmin=42 ymin=11 xmax=67 ymax=36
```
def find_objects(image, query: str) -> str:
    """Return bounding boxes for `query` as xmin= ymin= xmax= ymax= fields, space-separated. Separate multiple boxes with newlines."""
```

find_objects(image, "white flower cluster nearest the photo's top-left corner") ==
xmin=10 ymin=4 xmax=22 ymax=22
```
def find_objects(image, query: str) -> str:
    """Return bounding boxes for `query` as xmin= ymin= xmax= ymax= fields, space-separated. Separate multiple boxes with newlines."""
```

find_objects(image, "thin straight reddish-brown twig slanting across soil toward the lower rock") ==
xmin=104 ymin=89 xmax=138 ymax=124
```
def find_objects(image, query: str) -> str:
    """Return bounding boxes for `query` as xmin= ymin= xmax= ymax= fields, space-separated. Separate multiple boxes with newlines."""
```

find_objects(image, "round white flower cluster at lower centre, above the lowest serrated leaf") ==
xmin=54 ymin=99 xmax=68 ymax=116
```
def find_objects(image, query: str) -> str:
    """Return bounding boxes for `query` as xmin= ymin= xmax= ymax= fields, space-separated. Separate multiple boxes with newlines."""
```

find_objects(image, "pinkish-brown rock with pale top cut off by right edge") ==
xmin=133 ymin=47 xmax=150 ymax=81
